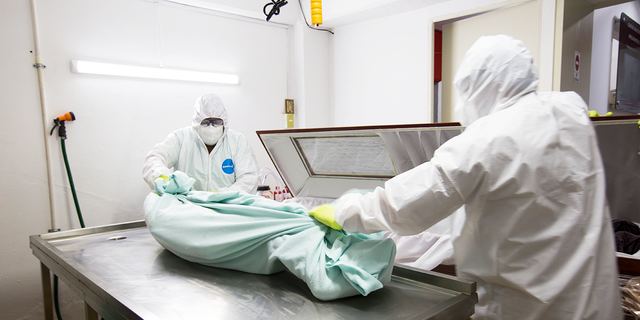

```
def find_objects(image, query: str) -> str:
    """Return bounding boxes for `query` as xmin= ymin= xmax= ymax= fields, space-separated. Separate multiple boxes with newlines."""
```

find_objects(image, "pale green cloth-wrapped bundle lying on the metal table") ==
xmin=144 ymin=171 xmax=396 ymax=300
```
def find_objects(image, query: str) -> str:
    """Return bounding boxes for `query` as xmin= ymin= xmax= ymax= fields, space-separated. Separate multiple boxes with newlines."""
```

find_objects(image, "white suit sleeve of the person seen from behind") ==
xmin=334 ymin=132 xmax=485 ymax=235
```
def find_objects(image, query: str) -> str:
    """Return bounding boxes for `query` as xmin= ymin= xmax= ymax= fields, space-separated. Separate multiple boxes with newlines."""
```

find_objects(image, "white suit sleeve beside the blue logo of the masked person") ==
xmin=228 ymin=136 xmax=260 ymax=194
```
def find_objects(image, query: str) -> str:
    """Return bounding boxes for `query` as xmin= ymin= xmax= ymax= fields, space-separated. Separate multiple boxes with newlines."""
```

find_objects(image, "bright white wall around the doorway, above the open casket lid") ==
xmin=331 ymin=0 xmax=555 ymax=126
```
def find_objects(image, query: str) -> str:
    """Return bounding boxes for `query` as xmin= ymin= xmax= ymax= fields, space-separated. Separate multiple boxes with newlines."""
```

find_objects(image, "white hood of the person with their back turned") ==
xmin=454 ymin=35 xmax=538 ymax=126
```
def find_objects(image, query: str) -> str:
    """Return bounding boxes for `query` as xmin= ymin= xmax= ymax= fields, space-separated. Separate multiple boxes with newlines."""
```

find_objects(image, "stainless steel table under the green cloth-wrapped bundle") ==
xmin=30 ymin=221 xmax=477 ymax=320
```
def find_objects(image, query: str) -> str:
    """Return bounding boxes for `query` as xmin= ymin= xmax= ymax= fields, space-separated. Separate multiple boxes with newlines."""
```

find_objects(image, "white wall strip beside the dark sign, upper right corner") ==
xmin=589 ymin=1 xmax=640 ymax=114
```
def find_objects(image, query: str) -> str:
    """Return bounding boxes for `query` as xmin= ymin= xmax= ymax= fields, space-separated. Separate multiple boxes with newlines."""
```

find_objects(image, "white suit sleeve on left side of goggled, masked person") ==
xmin=142 ymin=132 xmax=182 ymax=189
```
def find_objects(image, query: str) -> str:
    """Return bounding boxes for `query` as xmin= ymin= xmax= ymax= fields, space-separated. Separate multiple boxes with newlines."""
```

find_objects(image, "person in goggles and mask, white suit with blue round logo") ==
xmin=142 ymin=94 xmax=259 ymax=194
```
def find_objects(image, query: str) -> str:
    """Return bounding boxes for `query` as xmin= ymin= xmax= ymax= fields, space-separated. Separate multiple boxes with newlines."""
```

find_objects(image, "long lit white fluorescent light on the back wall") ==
xmin=71 ymin=60 xmax=240 ymax=84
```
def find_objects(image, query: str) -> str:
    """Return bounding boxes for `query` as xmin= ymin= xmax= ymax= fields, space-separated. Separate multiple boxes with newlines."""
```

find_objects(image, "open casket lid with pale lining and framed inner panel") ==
xmin=257 ymin=123 xmax=463 ymax=199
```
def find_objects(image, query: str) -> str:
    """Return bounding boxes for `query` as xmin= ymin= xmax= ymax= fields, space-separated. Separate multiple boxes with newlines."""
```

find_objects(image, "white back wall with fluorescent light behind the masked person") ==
xmin=38 ymin=0 xmax=287 ymax=229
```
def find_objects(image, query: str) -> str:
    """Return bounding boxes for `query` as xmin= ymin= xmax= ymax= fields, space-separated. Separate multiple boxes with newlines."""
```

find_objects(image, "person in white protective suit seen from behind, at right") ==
xmin=309 ymin=35 xmax=622 ymax=320
